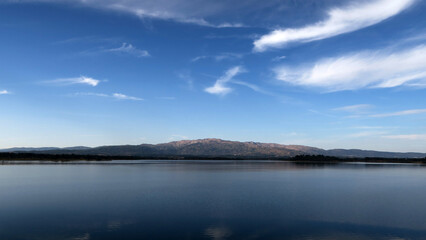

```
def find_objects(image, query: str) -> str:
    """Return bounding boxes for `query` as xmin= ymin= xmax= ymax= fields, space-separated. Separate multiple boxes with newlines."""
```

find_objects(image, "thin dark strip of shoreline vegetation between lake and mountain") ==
xmin=0 ymin=152 xmax=426 ymax=164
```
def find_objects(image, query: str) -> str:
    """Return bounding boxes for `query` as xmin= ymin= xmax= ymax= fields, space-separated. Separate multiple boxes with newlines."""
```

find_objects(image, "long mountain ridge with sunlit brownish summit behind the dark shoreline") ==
xmin=2 ymin=138 xmax=426 ymax=159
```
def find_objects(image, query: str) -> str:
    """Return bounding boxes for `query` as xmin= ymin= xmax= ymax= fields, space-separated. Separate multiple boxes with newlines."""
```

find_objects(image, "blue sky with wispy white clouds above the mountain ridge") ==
xmin=0 ymin=0 xmax=426 ymax=152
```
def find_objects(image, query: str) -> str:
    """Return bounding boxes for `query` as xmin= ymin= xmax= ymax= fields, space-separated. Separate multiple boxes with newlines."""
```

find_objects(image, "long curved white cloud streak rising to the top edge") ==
xmin=254 ymin=0 xmax=415 ymax=52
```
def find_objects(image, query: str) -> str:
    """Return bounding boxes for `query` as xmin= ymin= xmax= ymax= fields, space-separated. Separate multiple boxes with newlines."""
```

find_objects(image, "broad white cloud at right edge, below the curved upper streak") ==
xmin=275 ymin=45 xmax=426 ymax=91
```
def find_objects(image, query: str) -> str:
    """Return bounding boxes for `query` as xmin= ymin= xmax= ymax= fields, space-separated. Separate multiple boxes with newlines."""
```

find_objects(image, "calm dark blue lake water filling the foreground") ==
xmin=0 ymin=161 xmax=426 ymax=240
